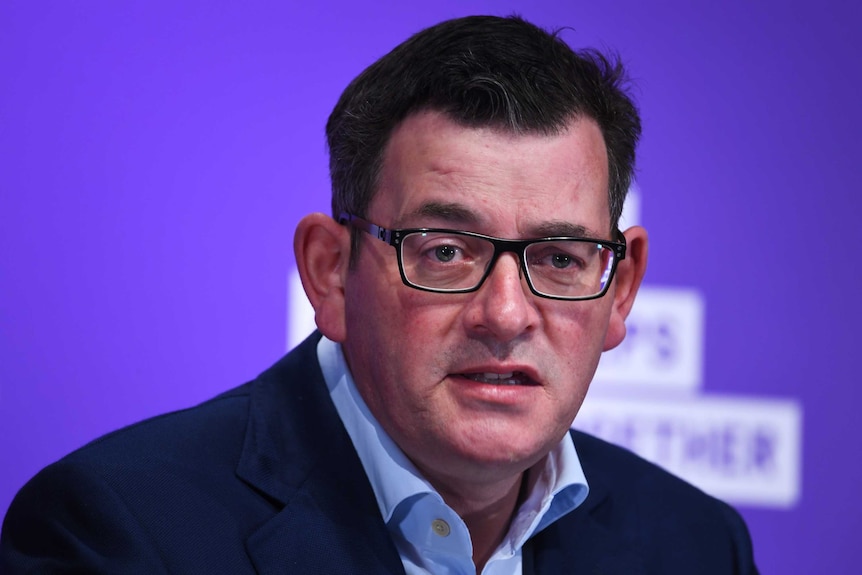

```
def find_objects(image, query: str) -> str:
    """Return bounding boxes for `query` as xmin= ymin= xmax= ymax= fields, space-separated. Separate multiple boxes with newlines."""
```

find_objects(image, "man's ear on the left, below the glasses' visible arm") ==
xmin=293 ymin=213 xmax=350 ymax=342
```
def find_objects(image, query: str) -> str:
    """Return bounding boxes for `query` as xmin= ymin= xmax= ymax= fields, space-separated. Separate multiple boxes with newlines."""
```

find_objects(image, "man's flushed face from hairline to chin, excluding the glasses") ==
xmin=343 ymin=112 xmax=614 ymax=484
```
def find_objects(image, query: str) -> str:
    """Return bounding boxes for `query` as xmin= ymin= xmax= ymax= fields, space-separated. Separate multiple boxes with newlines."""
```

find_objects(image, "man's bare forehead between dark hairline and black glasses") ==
xmin=369 ymin=111 xmax=610 ymax=237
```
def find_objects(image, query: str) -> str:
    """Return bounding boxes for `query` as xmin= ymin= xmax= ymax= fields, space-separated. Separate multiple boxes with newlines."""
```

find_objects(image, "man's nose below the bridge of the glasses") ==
xmin=464 ymin=253 xmax=538 ymax=341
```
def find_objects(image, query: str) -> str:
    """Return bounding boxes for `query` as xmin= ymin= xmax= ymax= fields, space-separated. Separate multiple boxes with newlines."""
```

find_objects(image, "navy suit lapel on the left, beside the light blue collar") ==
xmin=237 ymin=334 xmax=404 ymax=575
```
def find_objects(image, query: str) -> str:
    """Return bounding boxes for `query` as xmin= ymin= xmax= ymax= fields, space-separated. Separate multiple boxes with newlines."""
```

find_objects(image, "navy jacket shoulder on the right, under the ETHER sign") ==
xmin=560 ymin=431 xmax=757 ymax=574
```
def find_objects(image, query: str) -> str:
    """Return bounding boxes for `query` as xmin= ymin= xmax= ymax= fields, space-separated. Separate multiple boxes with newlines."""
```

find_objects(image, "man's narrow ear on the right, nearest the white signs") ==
xmin=604 ymin=226 xmax=648 ymax=351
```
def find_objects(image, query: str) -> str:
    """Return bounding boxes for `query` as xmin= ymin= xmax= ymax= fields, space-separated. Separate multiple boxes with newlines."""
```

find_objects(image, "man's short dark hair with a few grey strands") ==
xmin=326 ymin=16 xmax=641 ymax=245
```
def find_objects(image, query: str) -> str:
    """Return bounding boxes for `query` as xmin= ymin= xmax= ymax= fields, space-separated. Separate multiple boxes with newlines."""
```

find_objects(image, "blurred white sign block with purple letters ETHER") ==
xmin=574 ymin=395 xmax=802 ymax=507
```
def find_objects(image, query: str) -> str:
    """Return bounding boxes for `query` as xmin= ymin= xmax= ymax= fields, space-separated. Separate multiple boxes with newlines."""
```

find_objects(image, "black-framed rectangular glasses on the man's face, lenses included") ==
xmin=338 ymin=212 xmax=626 ymax=300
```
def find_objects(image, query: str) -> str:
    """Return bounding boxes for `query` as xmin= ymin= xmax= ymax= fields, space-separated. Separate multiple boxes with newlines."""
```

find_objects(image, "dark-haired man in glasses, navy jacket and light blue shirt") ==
xmin=0 ymin=13 xmax=756 ymax=575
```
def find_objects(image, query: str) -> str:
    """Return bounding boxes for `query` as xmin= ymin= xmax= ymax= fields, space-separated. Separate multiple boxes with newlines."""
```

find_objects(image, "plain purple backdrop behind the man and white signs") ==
xmin=0 ymin=0 xmax=862 ymax=574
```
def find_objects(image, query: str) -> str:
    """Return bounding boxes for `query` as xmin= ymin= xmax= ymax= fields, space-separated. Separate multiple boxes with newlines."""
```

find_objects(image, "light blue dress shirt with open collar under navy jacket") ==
xmin=317 ymin=337 xmax=589 ymax=575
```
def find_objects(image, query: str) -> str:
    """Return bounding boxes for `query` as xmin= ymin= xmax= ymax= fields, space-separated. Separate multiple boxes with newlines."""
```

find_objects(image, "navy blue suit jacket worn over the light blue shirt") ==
xmin=0 ymin=334 xmax=756 ymax=575
